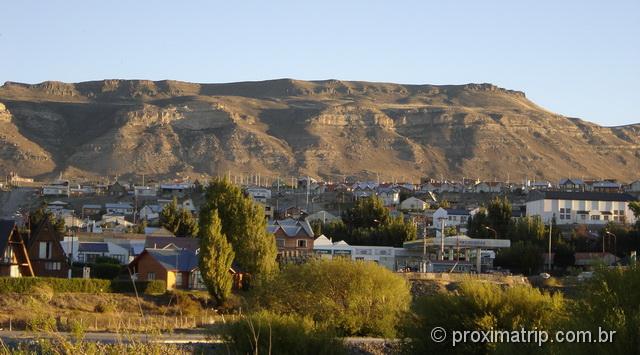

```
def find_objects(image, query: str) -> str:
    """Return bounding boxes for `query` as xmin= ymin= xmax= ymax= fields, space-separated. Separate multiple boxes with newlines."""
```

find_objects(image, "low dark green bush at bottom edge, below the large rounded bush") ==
xmin=222 ymin=311 xmax=346 ymax=355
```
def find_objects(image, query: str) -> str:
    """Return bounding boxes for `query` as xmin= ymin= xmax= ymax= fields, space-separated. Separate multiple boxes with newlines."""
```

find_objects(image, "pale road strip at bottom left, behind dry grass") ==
xmin=0 ymin=330 xmax=221 ymax=344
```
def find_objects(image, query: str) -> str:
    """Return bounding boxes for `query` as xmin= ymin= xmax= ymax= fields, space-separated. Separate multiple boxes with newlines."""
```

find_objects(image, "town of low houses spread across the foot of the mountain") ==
xmin=0 ymin=172 xmax=640 ymax=289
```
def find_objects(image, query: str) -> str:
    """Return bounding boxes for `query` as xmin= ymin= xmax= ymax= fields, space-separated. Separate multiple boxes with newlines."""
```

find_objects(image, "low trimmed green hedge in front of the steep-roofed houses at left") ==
xmin=0 ymin=277 xmax=167 ymax=294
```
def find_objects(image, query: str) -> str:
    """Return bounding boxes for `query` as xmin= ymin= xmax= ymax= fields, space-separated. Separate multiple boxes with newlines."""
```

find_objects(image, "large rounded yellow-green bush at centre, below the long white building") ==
xmin=251 ymin=260 xmax=411 ymax=337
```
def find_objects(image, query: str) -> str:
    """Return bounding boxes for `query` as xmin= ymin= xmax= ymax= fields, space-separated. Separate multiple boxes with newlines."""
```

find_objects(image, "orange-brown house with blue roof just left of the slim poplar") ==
xmin=129 ymin=249 xmax=206 ymax=290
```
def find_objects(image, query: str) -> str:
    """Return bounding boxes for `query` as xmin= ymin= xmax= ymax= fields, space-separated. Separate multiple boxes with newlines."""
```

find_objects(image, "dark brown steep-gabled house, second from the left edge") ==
xmin=27 ymin=218 xmax=69 ymax=277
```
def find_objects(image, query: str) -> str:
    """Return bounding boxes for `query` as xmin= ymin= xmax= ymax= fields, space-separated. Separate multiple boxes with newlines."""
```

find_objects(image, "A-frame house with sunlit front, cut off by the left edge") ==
xmin=0 ymin=220 xmax=34 ymax=277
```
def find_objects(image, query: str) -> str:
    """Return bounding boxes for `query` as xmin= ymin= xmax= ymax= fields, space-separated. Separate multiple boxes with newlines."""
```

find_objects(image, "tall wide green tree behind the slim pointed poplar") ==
xmin=200 ymin=179 xmax=278 ymax=275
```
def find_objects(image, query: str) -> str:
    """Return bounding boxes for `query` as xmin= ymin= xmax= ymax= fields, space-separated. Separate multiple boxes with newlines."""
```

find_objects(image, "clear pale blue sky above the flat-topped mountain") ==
xmin=0 ymin=0 xmax=640 ymax=125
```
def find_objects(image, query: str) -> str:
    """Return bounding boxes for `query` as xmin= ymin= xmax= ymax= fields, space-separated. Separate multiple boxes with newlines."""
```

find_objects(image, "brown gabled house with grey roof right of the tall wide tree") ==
xmin=267 ymin=218 xmax=314 ymax=258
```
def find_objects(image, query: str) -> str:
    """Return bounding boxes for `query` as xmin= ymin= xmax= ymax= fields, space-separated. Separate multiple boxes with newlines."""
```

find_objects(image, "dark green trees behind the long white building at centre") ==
xmin=312 ymin=196 xmax=416 ymax=247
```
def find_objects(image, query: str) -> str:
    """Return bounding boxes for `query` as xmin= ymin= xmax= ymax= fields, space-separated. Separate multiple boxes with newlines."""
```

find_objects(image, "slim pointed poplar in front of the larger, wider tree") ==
xmin=199 ymin=210 xmax=235 ymax=305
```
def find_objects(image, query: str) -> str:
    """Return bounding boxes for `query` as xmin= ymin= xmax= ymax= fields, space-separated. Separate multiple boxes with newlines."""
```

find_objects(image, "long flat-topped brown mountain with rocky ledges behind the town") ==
xmin=0 ymin=79 xmax=640 ymax=180
